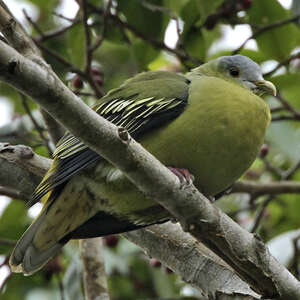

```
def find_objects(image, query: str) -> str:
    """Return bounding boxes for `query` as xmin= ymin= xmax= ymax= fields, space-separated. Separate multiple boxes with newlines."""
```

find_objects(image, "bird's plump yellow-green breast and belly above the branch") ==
xmin=142 ymin=78 xmax=269 ymax=195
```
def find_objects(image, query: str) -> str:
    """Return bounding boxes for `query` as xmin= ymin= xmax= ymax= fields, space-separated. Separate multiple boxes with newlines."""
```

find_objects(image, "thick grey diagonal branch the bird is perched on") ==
xmin=0 ymin=41 xmax=300 ymax=299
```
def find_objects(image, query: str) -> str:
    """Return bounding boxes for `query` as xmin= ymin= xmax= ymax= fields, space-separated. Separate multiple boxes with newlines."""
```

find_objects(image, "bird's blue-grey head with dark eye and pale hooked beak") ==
xmin=215 ymin=55 xmax=276 ymax=96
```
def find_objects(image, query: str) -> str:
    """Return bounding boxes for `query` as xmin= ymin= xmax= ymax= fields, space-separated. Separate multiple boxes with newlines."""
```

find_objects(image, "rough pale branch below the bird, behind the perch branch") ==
xmin=123 ymin=222 xmax=258 ymax=299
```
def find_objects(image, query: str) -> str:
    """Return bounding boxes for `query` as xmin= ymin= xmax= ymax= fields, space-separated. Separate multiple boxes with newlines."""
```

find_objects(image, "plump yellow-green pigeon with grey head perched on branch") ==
xmin=10 ymin=55 xmax=276 ymax=275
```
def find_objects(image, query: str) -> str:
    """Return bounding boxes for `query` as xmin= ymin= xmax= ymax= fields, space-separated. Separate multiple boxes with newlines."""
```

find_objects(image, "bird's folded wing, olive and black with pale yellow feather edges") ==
xmin=29 ymin=71 xmax=190 ymax=205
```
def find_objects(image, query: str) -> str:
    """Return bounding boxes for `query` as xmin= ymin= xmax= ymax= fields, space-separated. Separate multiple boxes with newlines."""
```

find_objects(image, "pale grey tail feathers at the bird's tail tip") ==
xmin=9 ymin=210 xmax=64 ymax=275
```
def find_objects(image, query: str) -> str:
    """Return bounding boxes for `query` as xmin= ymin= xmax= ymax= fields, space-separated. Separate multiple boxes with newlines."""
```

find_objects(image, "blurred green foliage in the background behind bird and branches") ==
xmin=0 ymin=0 xmax=300 ymax=300
